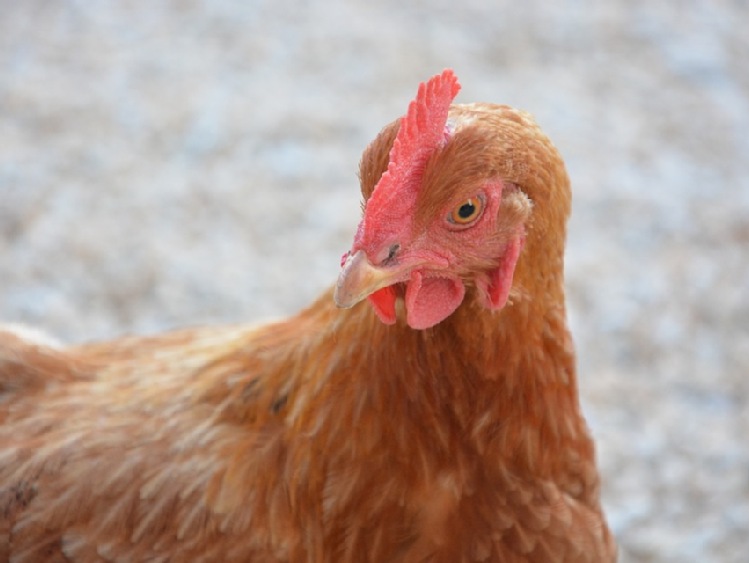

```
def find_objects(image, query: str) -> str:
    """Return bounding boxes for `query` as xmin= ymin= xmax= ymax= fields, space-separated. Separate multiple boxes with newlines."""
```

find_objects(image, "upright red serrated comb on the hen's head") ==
xmin=357 ymin=69 xmax=460 ymax=250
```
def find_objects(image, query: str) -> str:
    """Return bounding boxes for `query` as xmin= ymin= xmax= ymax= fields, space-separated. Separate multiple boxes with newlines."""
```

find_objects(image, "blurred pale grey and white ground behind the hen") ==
xmin=0 ymin=0 xmax=749 ymax=562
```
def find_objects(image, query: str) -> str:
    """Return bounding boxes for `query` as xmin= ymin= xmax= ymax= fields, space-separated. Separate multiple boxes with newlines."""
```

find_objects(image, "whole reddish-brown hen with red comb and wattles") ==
xmin=0 ymin=70 xmax=616 ymax=563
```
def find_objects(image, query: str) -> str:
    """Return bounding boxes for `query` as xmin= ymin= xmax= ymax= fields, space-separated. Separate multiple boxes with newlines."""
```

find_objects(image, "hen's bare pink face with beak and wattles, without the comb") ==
xmin=335 ymin=176 xmax=524 ymax=329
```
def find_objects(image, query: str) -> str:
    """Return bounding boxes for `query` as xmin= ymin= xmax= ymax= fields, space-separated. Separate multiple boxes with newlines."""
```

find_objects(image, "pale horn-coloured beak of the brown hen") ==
xmin=333 ymin=250 xmax=410 ymax=309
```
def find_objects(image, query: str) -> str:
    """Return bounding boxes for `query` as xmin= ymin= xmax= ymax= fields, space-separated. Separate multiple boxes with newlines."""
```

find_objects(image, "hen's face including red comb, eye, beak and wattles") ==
xmin=335 ymin=71 xmax=527 ymax=329
